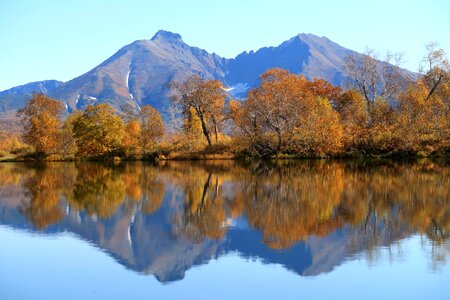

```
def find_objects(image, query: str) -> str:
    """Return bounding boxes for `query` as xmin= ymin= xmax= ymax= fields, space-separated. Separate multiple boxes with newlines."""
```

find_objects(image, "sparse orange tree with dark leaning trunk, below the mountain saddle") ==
xmin=171 ymin=76 xmax=226 ymax=146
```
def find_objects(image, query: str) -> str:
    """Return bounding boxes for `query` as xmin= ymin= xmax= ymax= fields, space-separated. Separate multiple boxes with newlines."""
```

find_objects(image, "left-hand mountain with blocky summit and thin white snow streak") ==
xmin=50 ymin=30 xmax=223 ymax=113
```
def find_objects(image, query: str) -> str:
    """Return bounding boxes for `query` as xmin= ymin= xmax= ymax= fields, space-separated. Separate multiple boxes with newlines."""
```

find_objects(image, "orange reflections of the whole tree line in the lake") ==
xmin=0 ymin=160 xmax=450 ymax=278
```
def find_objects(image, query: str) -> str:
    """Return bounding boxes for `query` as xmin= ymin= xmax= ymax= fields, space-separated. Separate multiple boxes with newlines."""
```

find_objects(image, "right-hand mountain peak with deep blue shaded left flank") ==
xmin=225 ymin=34 xmax=354 ymax=95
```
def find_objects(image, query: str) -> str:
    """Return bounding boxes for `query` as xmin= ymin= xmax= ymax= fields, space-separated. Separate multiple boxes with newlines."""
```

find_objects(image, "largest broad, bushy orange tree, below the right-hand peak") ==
xmin=229 ymin=69 xmax=341 ymax=156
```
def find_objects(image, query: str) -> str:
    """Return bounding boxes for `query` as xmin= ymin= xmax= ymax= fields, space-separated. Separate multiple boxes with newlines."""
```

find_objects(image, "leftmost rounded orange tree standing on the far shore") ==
xmin=18 ymin=93 xmax=64 ymax=156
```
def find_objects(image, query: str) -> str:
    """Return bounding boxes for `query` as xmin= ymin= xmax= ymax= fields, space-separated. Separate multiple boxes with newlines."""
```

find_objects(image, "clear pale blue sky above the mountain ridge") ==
xmin=0 ymin=0 xmax=450 ymax=90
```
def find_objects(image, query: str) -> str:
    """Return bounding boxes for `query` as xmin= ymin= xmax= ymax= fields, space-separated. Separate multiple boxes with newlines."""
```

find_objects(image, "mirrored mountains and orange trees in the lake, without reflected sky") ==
xmin=0 ymin=160 xmax=450 ymax=282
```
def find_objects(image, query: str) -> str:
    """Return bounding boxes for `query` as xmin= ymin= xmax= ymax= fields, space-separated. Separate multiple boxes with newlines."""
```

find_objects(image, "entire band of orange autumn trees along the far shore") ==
xmin=0 ymin=43 xmax=450 ymax=160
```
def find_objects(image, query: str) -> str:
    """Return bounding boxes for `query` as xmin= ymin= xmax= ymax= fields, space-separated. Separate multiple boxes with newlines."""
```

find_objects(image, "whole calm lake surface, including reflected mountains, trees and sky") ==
xmin=0 ymin=161 xmax=450 ymax=300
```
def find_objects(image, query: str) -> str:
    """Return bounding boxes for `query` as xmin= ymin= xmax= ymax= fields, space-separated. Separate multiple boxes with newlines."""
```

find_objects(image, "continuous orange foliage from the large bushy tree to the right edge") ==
xmin=227 ymin=69 xmax=450 ymax=156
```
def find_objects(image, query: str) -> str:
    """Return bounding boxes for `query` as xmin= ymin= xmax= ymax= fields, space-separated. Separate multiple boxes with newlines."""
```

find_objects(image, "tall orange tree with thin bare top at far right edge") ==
xmin=396 ymin=42 xmax=450 ymax=152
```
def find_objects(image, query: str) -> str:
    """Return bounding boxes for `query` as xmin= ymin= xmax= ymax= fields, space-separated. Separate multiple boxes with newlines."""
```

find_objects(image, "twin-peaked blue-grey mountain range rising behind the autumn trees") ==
xmin=0 ymin=30 xmax=409 ymax=125
